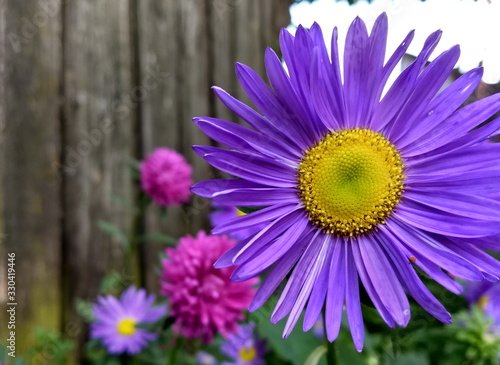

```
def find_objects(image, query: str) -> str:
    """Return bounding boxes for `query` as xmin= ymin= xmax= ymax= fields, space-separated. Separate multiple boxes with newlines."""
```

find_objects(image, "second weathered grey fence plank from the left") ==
xmin=61 ymin=0 xmax=136 ymax=356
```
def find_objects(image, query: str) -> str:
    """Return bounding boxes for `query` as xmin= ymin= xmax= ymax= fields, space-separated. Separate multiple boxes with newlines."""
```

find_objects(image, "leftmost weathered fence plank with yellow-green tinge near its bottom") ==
xmin=0 ymin=0 xmax=62 ymax=354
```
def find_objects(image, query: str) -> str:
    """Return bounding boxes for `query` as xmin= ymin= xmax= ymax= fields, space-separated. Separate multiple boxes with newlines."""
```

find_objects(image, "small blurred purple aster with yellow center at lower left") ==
xmin=90 ymin=286 xmax=167 ymax=355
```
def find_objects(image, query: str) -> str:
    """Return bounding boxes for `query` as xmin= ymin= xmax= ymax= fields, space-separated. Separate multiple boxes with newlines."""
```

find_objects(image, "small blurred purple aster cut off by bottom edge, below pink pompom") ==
xmin=221 ymin=323 xmax=266 ymax=365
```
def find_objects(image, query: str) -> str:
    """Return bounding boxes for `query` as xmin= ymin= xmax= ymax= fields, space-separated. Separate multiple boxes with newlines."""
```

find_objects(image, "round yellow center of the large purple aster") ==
xmin=298 ymin=128 xmax=405 ymax=236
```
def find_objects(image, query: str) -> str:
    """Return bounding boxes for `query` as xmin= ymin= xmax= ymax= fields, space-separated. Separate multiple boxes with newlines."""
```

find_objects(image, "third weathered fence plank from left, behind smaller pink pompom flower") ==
xmin=137 ymin=1 xmax=186 ymax=289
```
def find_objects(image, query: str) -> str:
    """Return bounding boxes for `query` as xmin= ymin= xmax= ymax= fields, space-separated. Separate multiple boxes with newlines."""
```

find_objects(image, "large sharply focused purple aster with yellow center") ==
xmin=192 ymin=14 xmax=500 ymax=351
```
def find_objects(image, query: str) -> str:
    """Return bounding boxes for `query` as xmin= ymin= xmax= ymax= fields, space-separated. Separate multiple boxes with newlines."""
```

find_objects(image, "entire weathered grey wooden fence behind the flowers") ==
xmin=0 ymin=0 xmax=291 ymax=354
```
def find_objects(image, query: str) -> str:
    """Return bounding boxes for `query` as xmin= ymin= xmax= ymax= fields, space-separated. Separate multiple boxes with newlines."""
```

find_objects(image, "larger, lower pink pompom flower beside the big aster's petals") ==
xmin=160 ymin=231 xmax=257 ymax=343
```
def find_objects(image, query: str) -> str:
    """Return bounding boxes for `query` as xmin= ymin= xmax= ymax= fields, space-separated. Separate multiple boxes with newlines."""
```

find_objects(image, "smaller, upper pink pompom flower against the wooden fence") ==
xmin=140 ymin=148 xmax=193 ymax=207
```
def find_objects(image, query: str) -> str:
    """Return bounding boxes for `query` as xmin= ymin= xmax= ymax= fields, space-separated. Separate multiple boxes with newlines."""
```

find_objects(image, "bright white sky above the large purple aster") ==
xmin=289 ymin=0 xmax=500 ymax=84
